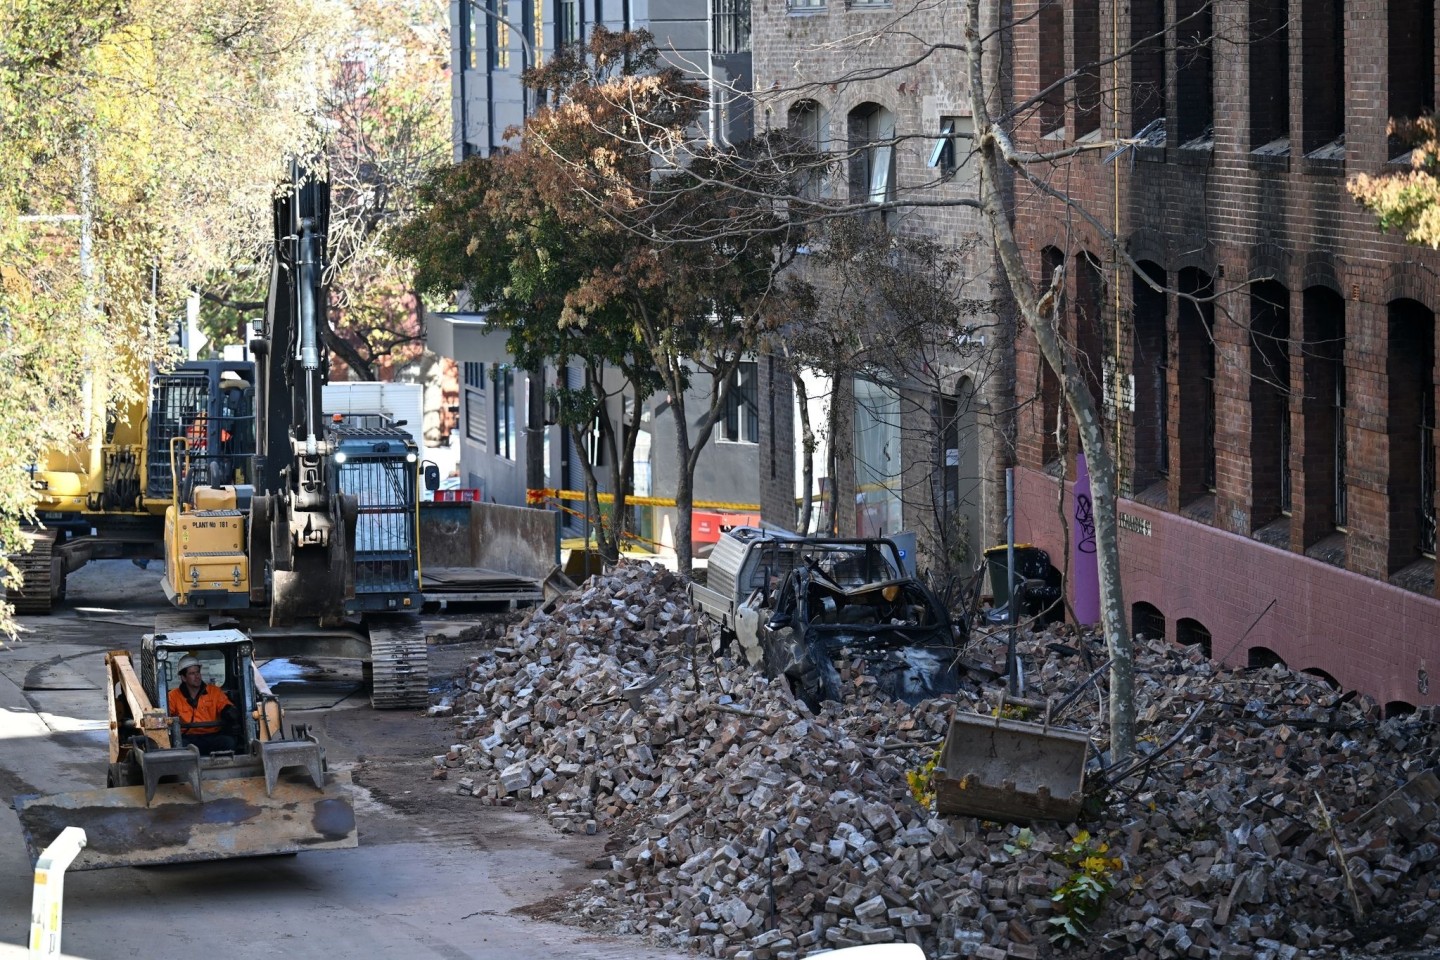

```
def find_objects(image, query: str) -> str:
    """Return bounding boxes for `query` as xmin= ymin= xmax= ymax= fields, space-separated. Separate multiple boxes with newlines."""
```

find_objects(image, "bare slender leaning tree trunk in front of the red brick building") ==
xmin=965 ymin=0 xmax=1135 ymax=761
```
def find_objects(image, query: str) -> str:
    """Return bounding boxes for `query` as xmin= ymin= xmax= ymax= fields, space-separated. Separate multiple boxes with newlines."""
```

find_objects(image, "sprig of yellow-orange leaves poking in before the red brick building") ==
xmin=1346 ymin=114 xmax=1440 ymax=249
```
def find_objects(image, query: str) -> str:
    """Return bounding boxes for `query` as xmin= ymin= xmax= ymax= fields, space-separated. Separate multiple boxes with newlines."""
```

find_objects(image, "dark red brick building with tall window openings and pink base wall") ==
xmin=1009 ymin=0 xmax=1440 ymax=710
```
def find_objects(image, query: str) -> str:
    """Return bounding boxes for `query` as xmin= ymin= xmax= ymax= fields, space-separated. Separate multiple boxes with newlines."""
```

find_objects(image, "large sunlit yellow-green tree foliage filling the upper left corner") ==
xmin=0 ymin=0 xmax=341 ymax=629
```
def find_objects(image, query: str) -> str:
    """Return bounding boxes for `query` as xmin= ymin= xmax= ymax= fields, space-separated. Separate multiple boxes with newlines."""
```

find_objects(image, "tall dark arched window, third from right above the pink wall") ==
xmin=1250 ymin=281 xmax=1290 ymax=530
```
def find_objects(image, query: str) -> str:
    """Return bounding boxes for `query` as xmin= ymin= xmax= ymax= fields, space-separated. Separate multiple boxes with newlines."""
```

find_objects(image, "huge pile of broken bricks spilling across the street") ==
xmin=438 ymin=564 xmax=1440 ymax=960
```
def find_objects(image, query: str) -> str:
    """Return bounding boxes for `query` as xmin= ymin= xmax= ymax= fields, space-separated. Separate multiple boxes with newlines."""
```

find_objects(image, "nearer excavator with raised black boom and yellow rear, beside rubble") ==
xmin=157 ymin=164 xmax=429 ymax=708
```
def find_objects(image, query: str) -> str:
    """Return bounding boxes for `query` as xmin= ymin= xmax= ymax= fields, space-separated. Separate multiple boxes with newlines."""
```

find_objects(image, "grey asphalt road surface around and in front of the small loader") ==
xmin=0 ymin=561 xmax=687 ymax=960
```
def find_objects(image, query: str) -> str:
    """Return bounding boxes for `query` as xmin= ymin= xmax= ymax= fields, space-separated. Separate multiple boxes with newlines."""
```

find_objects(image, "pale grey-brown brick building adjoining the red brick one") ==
xmin=752 ymin=0 xmax=1014 ymax=569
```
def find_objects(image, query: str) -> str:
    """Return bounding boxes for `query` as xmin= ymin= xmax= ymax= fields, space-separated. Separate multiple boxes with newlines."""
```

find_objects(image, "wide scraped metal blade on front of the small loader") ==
xmin=14 ymin=771 xmax=359 ymax=869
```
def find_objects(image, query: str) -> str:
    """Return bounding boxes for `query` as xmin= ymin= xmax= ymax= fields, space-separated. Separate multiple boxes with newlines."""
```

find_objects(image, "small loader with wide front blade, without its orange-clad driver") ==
xmin=14 ymin=630 xmax=359 ymax=869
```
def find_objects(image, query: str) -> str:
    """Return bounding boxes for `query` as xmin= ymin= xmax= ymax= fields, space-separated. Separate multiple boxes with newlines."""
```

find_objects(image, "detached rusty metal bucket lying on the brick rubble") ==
xmin=935 ymin=712 xmax=1090 ymax=823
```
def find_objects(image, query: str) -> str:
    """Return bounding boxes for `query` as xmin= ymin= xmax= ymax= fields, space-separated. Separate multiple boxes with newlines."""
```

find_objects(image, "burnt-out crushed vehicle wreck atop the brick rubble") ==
xmin=691 ymin=527 xmax=963 ymax=707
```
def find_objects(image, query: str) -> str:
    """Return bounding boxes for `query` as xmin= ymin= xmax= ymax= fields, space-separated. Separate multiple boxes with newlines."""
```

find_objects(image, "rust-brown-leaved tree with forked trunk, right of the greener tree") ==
xmin=521 ymin=27 xmax=801 ymax=571
